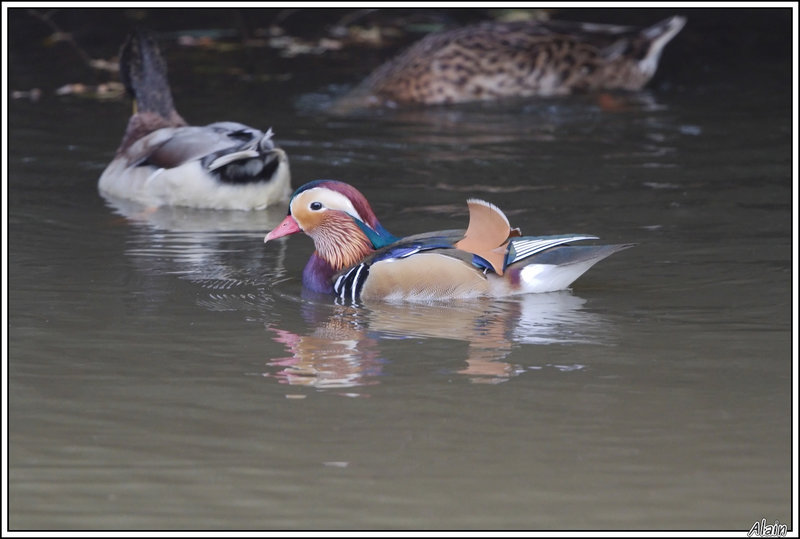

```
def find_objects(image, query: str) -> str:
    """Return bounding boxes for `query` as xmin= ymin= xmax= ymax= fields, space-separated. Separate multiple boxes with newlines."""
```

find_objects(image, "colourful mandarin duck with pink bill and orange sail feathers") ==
xmin=264 ymin=180 xmax=631 ymax=302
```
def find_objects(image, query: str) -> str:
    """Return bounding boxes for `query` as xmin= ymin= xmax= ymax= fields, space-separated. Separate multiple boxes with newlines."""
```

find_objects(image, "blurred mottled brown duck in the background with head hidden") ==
xmin=334 ymin=16 xmax=686 ymax=111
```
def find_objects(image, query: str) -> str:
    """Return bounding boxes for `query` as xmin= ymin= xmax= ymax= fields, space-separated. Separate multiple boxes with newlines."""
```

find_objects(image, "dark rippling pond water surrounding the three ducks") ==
xmin=6 ymin=9 xmax=796 ymax=531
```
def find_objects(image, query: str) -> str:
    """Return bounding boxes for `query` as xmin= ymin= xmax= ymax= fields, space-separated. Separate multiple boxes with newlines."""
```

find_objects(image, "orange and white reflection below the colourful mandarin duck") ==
xmin=265 ymin=292 xmax=608 ymax=389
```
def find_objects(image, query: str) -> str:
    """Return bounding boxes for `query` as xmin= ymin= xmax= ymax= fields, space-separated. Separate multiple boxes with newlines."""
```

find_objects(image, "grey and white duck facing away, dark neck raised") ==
xmin=98 ymin=32 xmax=291 ymax=210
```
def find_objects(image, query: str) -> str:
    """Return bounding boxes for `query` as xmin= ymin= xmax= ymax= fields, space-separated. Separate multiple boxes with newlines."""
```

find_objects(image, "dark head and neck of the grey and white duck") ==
xmin=119 ymin=30 xmax=183 ymax=123
